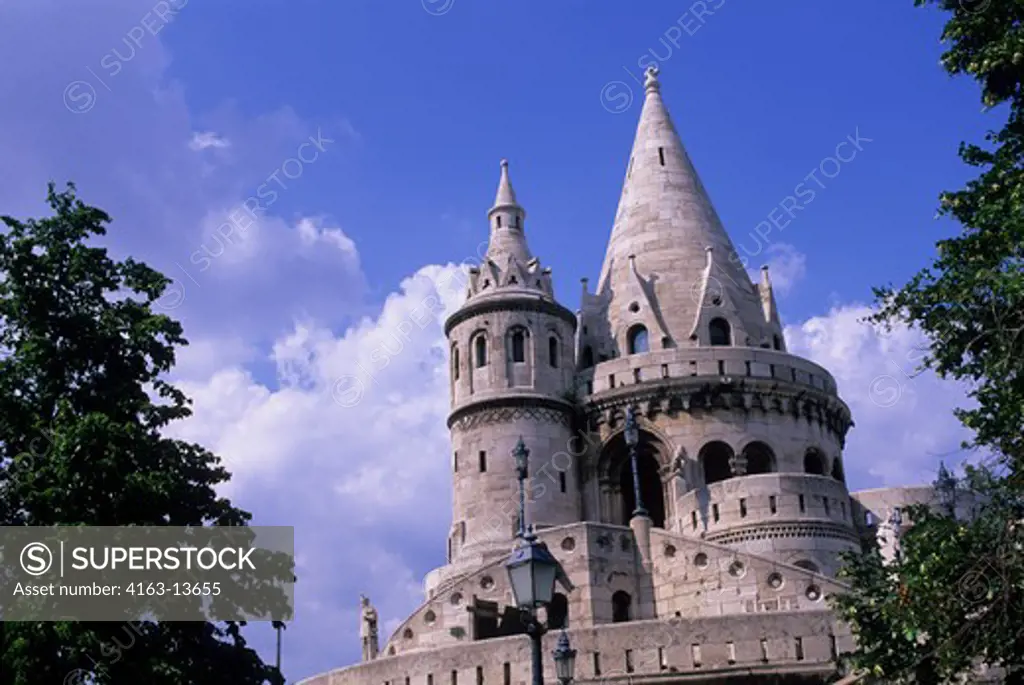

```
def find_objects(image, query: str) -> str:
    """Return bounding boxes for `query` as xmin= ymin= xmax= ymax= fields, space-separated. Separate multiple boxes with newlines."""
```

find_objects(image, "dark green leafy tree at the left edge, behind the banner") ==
xmin=0 ymin=184 xmax=284 ymax=685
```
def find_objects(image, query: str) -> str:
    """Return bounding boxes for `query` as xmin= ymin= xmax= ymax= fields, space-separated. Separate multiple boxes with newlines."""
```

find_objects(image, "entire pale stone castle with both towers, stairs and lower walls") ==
xmin=305 ymin=63 xmax=950 ymax=685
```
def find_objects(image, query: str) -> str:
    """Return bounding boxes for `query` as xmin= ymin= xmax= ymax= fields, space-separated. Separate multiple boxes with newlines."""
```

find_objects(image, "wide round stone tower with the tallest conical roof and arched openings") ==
xmin=579 ymin=70 xmax=858 ymax=573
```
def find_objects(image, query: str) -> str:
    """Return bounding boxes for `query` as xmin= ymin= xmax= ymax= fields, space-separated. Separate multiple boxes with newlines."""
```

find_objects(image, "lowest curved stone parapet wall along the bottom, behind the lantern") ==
xmin=299 ymin=611 xmax=853 ymax=685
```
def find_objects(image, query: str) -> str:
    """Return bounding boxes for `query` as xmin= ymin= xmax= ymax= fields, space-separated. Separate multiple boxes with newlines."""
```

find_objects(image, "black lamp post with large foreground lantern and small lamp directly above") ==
xmin=505 ymin=437 xmax=572 ymax=685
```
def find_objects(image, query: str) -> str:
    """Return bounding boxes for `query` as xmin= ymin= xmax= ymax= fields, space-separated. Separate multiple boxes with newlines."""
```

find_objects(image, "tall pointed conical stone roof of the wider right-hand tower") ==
xmin=597 ymin=68 xmax=771 ymax=349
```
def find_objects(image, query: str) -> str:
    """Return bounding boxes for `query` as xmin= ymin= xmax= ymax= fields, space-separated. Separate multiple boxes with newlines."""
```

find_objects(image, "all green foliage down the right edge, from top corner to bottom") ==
xmin=833 ymin=0 xmax=1024 ymax=683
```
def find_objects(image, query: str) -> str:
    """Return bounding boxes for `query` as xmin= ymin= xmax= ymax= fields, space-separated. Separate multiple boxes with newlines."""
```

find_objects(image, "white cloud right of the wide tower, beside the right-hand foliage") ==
xmin=785 ymin=304 xmax=968 ymax=487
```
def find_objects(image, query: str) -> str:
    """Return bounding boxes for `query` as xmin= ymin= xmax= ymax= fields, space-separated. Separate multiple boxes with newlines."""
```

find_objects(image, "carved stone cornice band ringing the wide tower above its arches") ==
xmin=583 ymin=376 xmax=853 ymax=444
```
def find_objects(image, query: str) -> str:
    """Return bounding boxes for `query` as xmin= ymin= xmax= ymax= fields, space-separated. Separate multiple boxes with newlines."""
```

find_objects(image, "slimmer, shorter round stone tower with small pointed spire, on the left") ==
xmin=444 ymin=160 xmax=580 ymax=566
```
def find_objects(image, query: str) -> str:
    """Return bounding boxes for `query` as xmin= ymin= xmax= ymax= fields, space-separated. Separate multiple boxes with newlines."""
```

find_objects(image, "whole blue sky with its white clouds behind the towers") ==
xmin=0 ymin=0 xmax=995 ymax=679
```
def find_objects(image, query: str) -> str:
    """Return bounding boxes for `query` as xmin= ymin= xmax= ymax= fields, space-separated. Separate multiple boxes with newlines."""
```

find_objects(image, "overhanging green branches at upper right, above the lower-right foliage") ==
xmin=873 ymin=0 xmax=1024 ymax=474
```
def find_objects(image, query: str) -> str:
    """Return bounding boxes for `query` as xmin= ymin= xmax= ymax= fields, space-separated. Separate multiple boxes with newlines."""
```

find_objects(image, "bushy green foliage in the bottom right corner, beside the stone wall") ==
xmin=831 ymin=468 xmax=1024 ymax=685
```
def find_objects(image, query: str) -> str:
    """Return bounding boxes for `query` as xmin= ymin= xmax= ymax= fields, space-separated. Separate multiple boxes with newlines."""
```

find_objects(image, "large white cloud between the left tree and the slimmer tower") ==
xmin=162 ymin=264 xmax=465 ymax=675
